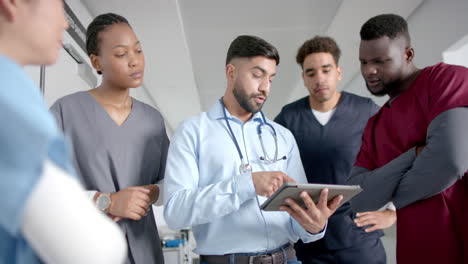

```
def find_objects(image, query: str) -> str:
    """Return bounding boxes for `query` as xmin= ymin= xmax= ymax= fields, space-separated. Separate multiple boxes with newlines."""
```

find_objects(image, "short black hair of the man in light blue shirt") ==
xmin=226 ymin=35 xmax=279 ymax=65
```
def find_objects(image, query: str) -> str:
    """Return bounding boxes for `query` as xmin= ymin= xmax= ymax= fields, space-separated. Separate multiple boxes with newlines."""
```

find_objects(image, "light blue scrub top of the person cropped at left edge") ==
xmin=0 ymin=55 xmax=73 ymax=264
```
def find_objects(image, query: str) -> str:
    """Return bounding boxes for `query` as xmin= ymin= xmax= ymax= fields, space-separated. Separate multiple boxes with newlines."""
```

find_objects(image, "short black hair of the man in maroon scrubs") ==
xmin=360 ymin=14 xmax=411 ymax=43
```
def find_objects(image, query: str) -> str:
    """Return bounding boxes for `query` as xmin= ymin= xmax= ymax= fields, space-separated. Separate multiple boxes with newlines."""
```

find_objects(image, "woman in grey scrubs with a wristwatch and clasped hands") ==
xmin=51 ymin=13 xmax=169 ymax=263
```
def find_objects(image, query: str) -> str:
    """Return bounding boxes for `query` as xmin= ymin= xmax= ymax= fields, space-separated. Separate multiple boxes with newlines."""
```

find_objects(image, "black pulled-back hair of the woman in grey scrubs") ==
xmin=86 ymin=13 xmax=130 ymax=55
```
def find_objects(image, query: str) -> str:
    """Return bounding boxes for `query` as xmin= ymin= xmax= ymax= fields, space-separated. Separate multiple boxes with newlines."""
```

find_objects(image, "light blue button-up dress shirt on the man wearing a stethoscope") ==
xmin=164 ymin=101 xmax=325 ymax=255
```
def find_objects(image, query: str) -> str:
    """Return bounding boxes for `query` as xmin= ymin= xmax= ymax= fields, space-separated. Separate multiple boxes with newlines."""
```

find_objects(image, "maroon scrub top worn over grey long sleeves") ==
xmin=355 ymin=63 xmax=468 ymax=264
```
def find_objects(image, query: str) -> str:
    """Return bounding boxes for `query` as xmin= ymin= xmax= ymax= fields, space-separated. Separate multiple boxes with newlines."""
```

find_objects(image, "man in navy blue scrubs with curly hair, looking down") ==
xmin=275 ymin=36 xmax=396 ymax=263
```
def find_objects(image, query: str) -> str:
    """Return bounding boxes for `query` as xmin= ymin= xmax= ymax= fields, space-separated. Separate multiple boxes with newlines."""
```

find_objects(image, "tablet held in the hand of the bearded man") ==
xmin=261 ymin=183 xmax=362 ymax=211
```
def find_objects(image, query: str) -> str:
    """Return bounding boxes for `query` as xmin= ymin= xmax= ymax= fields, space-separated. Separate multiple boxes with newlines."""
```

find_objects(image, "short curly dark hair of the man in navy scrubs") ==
xmin=296 ymin=36 xmax=341 ymax=68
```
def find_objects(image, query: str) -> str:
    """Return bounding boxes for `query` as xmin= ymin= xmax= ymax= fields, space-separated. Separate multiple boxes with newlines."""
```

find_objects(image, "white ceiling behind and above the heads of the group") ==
xmin=82 ymin=0 xmax=423 ymax=129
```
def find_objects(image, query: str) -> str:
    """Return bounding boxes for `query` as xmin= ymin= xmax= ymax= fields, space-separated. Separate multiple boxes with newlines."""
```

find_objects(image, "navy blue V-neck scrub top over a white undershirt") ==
xmin=275 ymin=92 xmax=383 ymax=250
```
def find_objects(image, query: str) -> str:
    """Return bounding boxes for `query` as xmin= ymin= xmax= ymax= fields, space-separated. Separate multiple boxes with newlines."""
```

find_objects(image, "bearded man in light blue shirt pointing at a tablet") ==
xmin=164 ymin=36 xmax=341 ymax=264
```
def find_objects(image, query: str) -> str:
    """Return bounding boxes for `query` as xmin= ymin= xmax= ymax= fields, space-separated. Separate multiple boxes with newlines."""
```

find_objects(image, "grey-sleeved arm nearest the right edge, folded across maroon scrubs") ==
xmin=392 ymin=107 xmax=468 ymax=208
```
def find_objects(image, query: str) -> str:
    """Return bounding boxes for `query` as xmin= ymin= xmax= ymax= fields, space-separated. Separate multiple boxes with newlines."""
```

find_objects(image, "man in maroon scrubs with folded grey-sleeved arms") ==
xmin=348 ymin=14 xmax=468 ymax=264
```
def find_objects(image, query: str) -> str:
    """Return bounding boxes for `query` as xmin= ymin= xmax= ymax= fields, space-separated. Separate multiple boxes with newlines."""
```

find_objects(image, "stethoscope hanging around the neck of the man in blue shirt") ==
xmin=219 ymin=97 xmax=287 ymax=174
